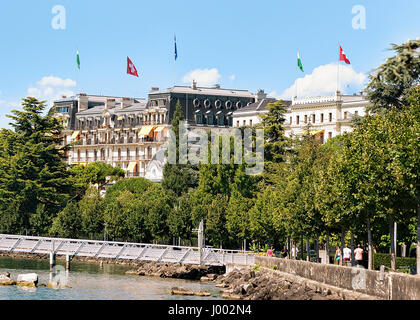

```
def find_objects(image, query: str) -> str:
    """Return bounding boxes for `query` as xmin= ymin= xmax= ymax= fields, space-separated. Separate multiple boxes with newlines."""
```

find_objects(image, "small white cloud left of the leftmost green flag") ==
xmin=27 ymin=76 xmax=77 ymax=106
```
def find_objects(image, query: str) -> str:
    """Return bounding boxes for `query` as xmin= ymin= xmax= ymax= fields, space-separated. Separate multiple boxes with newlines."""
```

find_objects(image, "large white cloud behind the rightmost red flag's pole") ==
xmin=280 ymin=63 xmax=367 ymax=100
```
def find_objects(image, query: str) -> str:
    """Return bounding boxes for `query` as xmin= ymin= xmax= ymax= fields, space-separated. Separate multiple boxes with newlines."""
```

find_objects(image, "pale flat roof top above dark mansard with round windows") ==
xmin=149 ymin=86 xmax=254 ymax=98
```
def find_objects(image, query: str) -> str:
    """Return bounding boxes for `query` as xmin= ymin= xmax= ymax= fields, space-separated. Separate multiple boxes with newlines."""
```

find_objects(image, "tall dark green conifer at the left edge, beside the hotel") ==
xmin=0 ymin=97 xmax=71 ymax=230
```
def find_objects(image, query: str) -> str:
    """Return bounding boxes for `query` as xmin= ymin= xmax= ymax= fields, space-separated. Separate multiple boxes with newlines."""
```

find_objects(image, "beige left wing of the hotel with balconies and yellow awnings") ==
xmin=55 ymin=94 xmax=168 ymax=177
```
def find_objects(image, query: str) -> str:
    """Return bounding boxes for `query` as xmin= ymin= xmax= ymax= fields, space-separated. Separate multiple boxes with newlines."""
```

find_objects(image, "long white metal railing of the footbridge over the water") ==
xmin=0 ymin=234 xmax=254 ymax=265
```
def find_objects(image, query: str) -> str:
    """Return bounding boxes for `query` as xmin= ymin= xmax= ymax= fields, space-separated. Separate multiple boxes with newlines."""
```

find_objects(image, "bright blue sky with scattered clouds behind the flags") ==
xmin=0 ymin=0 xmax=420 ymax=127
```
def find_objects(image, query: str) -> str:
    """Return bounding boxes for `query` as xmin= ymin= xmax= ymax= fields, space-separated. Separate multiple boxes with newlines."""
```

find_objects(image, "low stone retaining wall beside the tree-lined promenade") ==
xmin=255 ymin=256 xmax=420 ymax=300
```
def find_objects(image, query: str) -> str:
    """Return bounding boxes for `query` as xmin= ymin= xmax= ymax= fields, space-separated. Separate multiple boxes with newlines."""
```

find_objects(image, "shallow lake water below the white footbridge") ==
xmin=0 ymin=257 xmax=221 ymax=300
